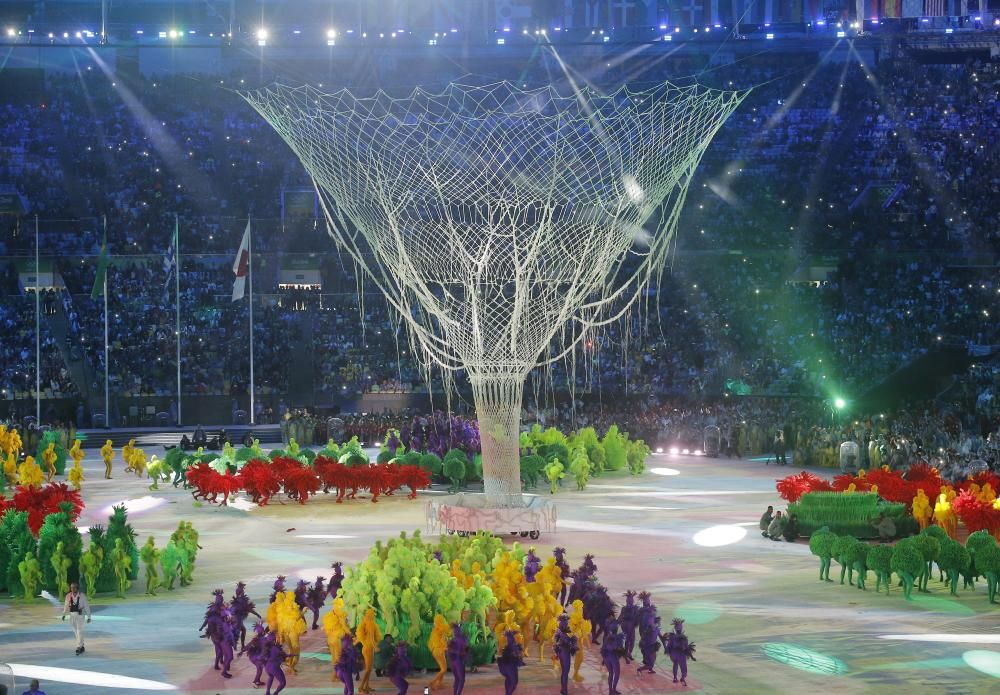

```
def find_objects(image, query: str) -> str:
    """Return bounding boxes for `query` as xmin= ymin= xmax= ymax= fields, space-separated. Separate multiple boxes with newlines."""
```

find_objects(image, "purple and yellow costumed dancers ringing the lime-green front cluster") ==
xmin=201 ymin=548 xmax=695 ymax=695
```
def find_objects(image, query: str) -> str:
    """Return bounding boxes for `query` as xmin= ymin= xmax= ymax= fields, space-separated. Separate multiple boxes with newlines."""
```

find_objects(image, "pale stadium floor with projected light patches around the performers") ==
xmin=0 ymin=450 xmax=1000 ymax=695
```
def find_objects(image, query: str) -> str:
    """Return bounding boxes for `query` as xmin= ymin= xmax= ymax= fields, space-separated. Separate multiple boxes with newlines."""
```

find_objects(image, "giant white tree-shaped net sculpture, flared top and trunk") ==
xmin=244 ymin=82 xmax=746 ymax=507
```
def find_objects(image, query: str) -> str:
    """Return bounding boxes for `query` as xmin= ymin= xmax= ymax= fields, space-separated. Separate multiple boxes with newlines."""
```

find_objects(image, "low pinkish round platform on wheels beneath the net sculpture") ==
xmin=427 ymin=492 xmax=556 ymax=538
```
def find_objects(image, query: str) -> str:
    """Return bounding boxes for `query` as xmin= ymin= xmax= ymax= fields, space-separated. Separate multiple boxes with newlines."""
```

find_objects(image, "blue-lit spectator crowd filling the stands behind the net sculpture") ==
xmin=0 ymin=59 xmax=1000 ymax=458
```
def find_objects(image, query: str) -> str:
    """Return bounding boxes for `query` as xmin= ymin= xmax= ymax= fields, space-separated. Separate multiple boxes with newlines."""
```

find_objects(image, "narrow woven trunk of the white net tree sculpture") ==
xmin=469 ymin=374 xmax=524 ymax=507
